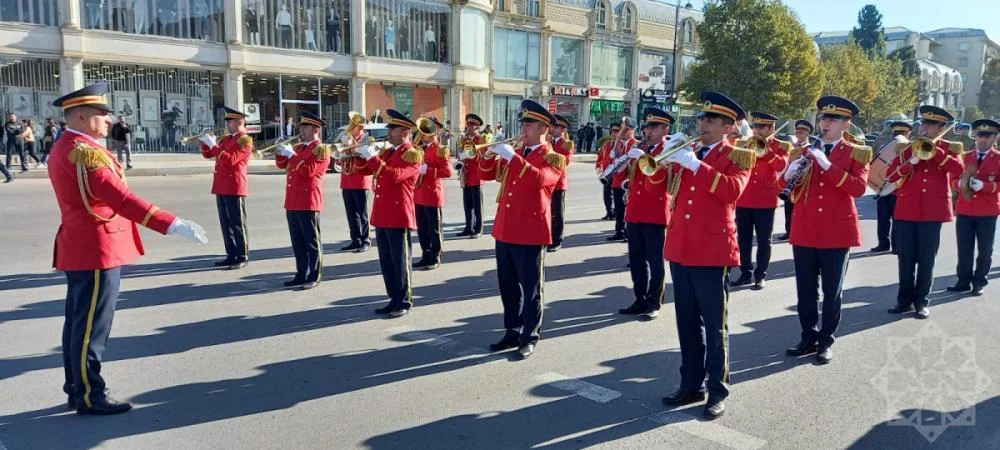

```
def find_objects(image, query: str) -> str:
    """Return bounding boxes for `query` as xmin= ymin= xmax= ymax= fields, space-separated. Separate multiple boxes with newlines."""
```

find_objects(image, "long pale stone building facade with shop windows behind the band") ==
xmin=0 ymin=0 xmax=699 ymax=151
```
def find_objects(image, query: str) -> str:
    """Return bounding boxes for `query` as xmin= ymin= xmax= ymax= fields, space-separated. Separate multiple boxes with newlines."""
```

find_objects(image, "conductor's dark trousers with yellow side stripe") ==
xmin=62 ymin=267 xmax=121 ymax=407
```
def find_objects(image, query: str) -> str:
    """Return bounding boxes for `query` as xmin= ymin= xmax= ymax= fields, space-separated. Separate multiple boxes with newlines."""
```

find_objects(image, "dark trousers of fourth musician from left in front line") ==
xmin=496 ymin=241 xmax=545 ymax=345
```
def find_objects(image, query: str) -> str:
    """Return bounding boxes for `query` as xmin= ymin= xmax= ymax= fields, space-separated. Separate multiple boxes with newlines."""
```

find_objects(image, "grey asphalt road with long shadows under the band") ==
xmin=0 ymin=165 xmax=1000 ymax=450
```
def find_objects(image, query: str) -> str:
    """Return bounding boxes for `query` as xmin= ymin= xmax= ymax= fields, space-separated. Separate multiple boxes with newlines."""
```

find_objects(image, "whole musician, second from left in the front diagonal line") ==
xmin=274 ymin=111 xmax=330 ymax=291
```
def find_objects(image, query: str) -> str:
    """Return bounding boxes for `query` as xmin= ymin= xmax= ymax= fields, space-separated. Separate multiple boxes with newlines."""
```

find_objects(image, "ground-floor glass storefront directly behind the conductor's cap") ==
xmin=83 ymin=63 xmax=224 ymax=152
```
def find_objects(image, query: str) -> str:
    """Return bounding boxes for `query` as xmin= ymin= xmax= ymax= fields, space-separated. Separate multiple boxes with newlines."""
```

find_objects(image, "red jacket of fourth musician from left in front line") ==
xmin=480 ymin=144 xmax=566 ymax=245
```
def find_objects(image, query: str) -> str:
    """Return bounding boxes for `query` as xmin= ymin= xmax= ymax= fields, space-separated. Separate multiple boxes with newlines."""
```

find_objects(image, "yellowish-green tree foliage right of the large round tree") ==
xmin=822 ymin=43 xmax=917 ymax=128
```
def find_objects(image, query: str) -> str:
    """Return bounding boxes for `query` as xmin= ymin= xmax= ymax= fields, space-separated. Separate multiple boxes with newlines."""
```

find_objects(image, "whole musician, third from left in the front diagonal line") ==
xmin=358 ymin=109 xmax=423 ymax=317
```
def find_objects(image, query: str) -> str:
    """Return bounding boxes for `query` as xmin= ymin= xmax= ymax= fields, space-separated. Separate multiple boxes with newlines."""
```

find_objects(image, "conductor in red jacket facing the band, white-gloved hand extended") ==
xmin=48 ymin=83 xmax=207 ymax=415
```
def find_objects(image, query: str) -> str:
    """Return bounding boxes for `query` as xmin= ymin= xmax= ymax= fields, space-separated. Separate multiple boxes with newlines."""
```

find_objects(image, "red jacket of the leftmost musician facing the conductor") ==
xmin=201 ymin=133 xmax=253 ymax=197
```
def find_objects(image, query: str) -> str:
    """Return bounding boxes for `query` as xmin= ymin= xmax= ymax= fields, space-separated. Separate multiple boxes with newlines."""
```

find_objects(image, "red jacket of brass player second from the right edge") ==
xmin=886 ymin=140 xmax=962 ymax=222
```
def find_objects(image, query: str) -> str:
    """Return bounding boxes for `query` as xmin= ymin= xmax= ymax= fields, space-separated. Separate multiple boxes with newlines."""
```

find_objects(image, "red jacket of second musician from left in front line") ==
xmin=274 ymin=139 xmax=330 ymax=211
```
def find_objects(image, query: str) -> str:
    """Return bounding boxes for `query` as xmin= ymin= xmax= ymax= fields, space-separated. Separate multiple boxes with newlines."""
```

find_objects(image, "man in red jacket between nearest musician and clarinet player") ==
xmin=732 ymin=112 xmax=792 ymax=291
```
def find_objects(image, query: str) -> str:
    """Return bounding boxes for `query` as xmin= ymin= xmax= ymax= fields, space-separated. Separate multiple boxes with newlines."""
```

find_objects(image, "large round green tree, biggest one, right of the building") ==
xmin=680 ymin=0 xmax=822 ymax=118
